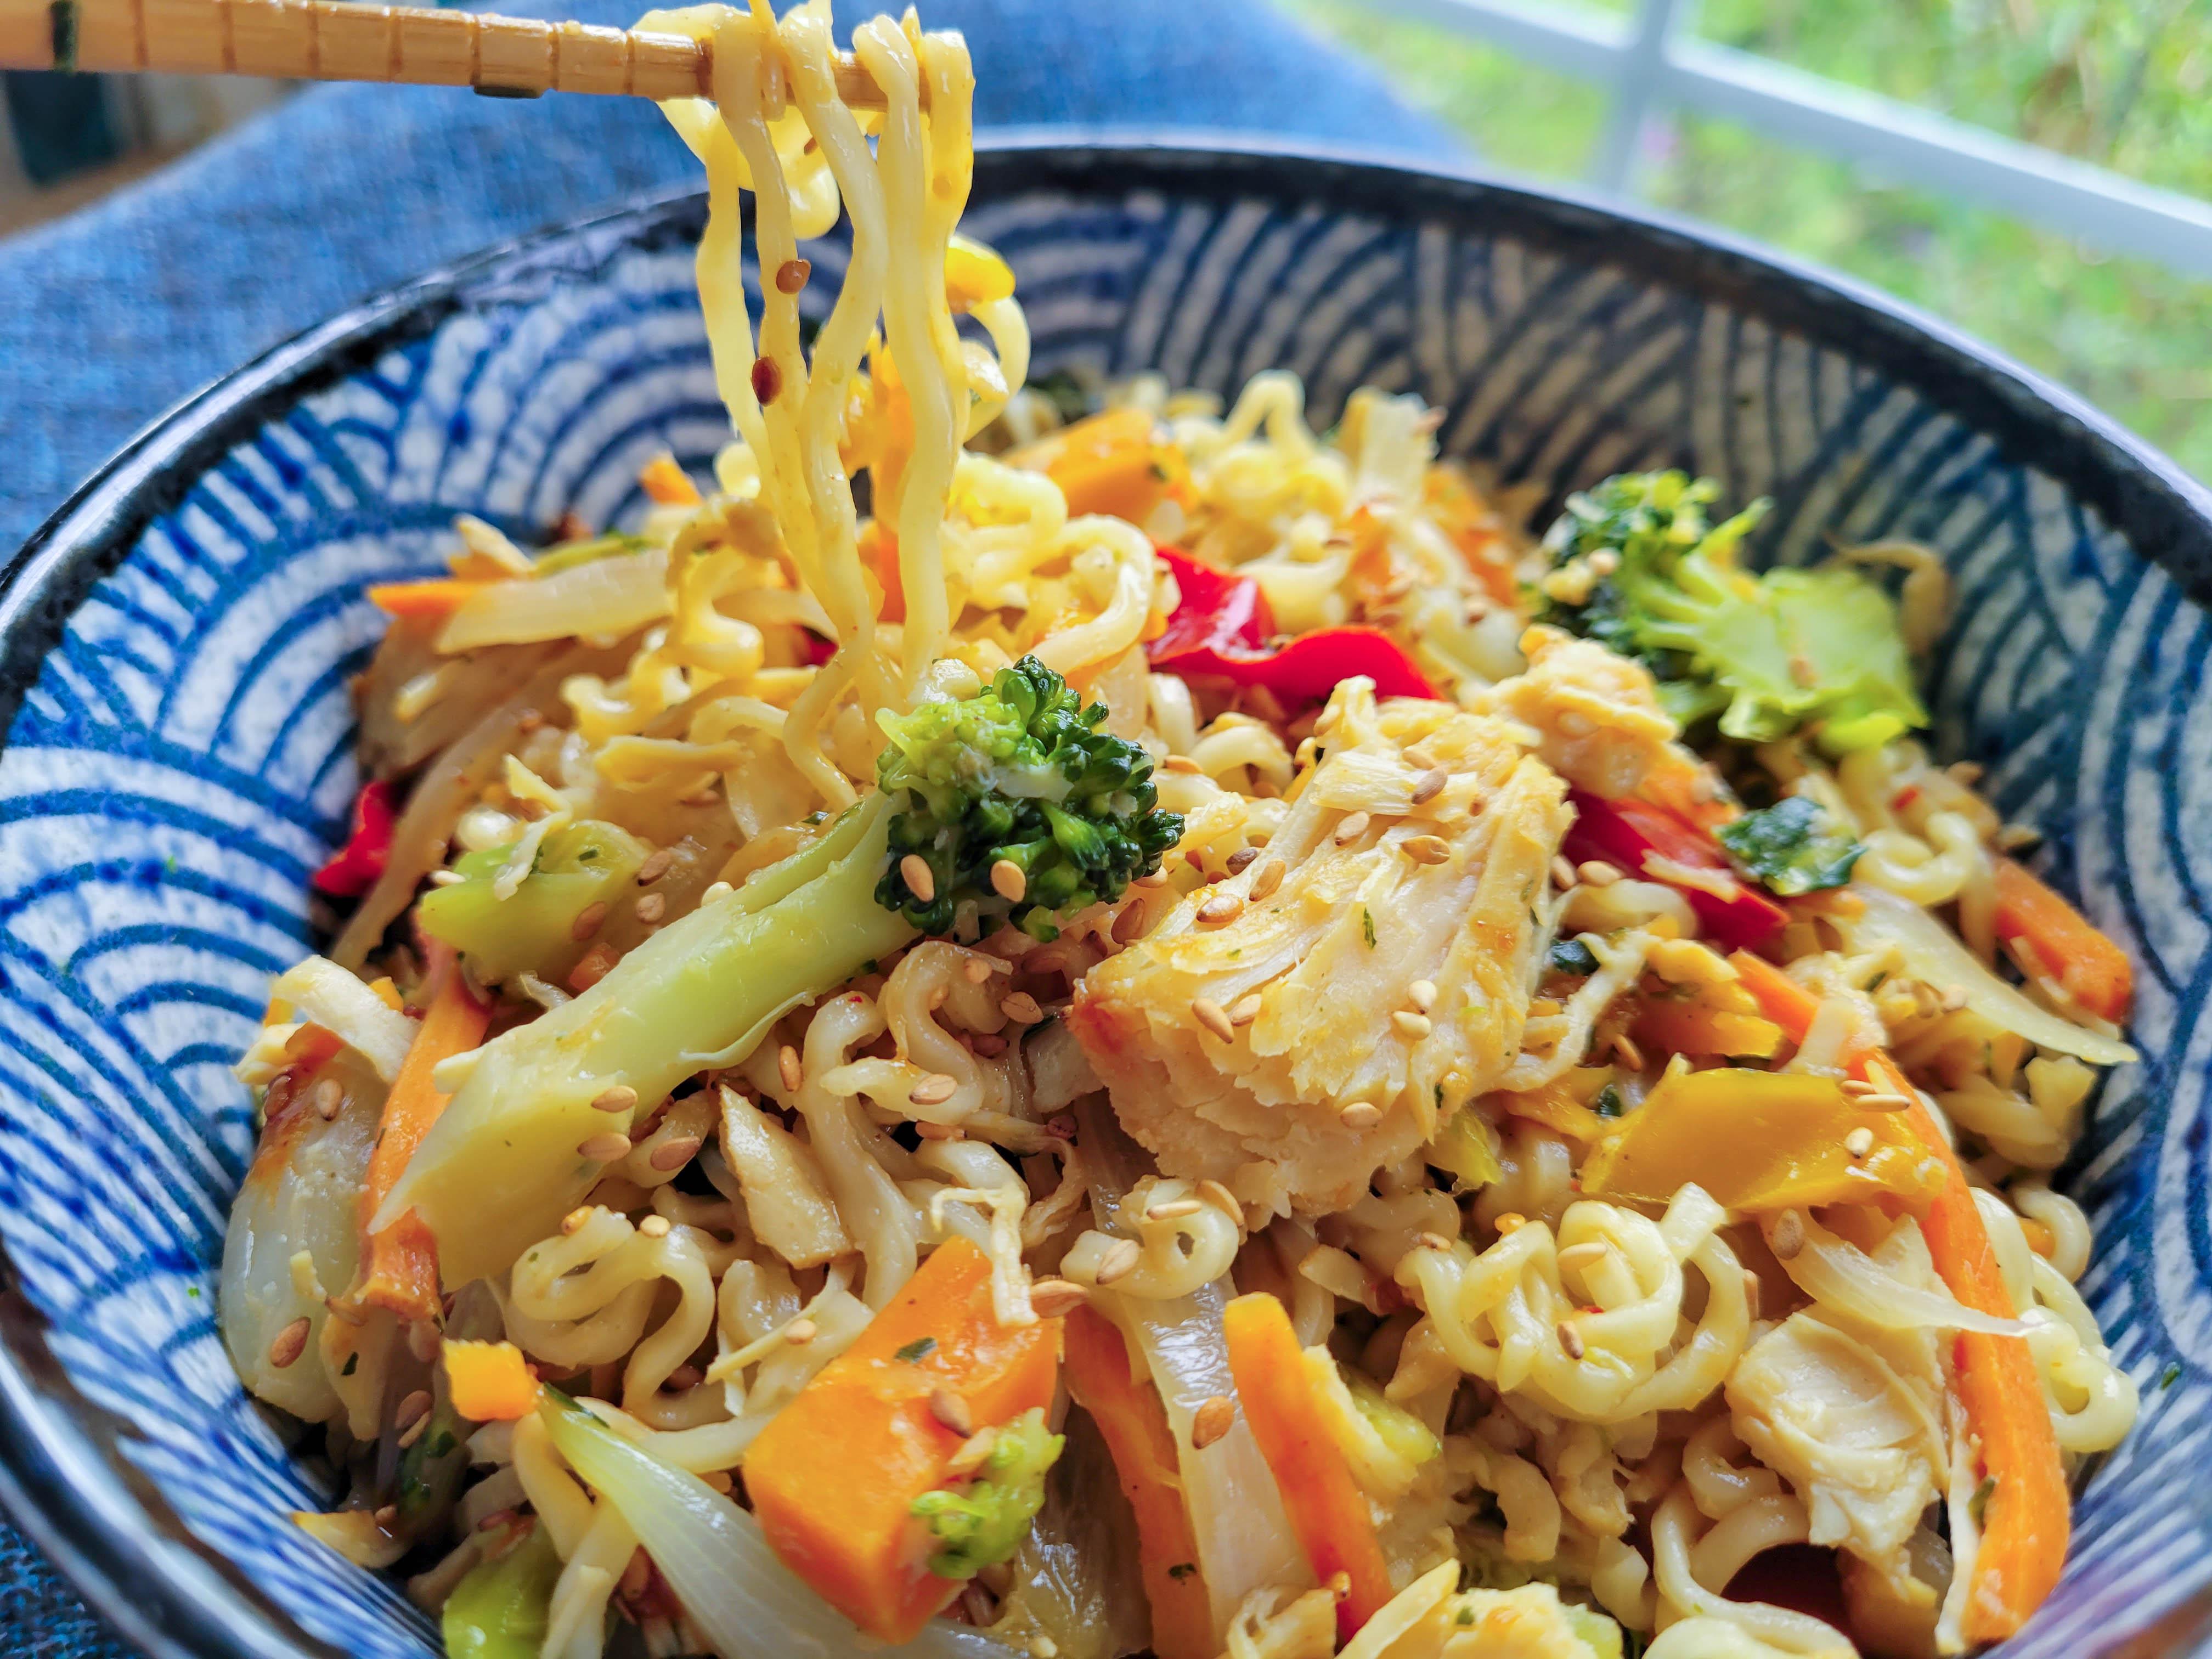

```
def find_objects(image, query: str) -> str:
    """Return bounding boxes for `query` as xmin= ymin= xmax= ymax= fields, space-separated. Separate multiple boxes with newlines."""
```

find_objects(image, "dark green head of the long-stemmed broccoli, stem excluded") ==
xmin=876 ymin=657 xmax=1183 ymax=934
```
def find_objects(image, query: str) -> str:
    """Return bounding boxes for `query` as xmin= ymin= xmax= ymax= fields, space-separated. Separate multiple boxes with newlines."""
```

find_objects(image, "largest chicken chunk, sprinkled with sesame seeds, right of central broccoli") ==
xmin=1068 ymin=679 xmax=1571 ymax=1215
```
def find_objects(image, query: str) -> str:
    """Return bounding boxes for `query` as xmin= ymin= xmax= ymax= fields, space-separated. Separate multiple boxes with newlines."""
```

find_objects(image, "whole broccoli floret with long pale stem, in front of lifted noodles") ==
xmin=376 ymin=657 xmax=1183 ymax=1285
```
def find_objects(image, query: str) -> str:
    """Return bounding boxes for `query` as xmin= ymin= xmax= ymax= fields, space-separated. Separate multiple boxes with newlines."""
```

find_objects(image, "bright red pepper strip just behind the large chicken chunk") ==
xmin=1146 ymin=546 xmax=1440 ymax=708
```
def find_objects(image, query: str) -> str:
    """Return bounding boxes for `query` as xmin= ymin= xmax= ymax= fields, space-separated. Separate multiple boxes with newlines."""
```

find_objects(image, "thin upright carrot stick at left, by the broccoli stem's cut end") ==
xmin=354 ymin=953 xmax=491 ymax=1323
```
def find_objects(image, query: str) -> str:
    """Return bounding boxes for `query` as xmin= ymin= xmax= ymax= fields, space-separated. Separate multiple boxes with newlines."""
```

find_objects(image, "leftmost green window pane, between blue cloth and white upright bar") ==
xmin=1285 ymin=0 xmax=1628 ymax=179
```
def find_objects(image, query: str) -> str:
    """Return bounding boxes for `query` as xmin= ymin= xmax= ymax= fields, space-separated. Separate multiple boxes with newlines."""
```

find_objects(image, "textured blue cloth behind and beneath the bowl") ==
xmin=0 ymin=0 xmax=1458 ymax=1659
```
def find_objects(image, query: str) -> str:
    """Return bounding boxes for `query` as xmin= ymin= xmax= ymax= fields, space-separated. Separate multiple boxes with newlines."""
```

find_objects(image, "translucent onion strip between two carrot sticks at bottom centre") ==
xmin=1075 ymin=1095 xmax=1314 ymax=1633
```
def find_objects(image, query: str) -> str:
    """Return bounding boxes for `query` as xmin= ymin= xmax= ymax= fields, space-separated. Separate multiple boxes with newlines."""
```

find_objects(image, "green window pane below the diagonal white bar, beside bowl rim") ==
xmin=1644 ymin=117 xmax=2212 ymax=478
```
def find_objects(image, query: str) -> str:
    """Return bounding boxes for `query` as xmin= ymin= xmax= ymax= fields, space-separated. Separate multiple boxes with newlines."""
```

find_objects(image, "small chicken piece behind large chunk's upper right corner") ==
xmin=1493 ymin=628 xmax=1674 ymax=801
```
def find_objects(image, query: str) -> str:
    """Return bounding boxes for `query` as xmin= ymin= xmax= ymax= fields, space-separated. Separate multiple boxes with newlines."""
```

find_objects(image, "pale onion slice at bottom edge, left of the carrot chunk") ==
xmin=542 ymin=1400 xmax=1013 ymax=1659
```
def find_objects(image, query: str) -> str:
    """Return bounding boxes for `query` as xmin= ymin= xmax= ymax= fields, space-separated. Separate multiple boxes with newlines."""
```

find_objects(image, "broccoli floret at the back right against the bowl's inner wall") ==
xmin=1537 ymin=471 xmax=1927 ymax=754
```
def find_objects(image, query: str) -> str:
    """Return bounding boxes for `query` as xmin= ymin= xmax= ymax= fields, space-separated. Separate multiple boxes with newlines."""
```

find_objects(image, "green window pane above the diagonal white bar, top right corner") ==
xmin=1697 ymin=0 xmax=2212 ymax=197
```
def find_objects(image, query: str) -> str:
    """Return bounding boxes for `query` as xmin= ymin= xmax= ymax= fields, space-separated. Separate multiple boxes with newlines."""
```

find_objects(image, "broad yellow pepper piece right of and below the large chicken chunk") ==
xmin=1582 ymin=1068 xmax=1942 ymax=1212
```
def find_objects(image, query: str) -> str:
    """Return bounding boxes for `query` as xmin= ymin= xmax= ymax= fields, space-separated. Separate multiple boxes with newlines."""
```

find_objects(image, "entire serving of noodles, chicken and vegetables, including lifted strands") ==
xmin=221 ymin=0 xmax=2135 ymax=1659
